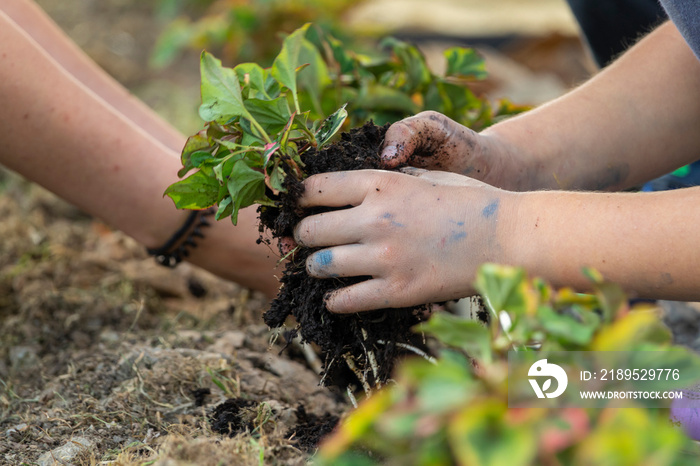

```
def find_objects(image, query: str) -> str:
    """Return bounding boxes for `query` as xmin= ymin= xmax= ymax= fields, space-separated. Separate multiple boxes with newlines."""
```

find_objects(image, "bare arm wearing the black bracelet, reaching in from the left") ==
xmin=0 ymin=12 xmax=277 ymax=294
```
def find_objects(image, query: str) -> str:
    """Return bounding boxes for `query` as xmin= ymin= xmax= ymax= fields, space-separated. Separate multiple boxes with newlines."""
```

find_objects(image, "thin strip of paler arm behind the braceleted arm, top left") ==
xmin=0 ymin=0 xmax=184 ymax=151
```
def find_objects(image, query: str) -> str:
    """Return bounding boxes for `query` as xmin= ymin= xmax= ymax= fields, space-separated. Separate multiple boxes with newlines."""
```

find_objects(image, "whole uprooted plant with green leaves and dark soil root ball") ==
xmin=166 ymin=24 xmax=524 ymax=394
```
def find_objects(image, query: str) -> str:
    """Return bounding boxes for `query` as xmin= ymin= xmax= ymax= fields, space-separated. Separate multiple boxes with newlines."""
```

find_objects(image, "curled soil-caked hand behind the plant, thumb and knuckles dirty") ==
xmin=381 ymin=111 xmax=504 ymax=184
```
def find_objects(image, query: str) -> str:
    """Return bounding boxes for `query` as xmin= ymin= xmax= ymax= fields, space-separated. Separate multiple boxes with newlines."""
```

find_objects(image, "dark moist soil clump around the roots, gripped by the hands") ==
xmin=260 ymin=123 xmax=425 ymax=388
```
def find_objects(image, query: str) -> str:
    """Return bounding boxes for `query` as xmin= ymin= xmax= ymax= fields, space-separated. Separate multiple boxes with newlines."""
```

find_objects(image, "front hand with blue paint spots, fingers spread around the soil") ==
xmin=294 ymin=167 xmax=518 ymax=313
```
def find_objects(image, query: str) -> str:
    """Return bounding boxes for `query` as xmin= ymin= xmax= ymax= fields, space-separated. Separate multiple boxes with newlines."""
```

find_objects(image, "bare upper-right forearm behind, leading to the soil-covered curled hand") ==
xmin=482 ymin=23 xmax=700 ymax=191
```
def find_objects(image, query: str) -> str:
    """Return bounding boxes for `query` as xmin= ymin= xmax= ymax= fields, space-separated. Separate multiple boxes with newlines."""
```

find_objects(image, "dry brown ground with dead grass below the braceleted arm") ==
xmin=0 ymin=174 xmax=345 ymax=465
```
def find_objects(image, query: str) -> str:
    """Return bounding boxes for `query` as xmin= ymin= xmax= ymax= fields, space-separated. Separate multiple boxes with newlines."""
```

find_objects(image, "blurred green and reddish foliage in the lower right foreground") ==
xmin=316 ymin=264 xmax=700 ymax=466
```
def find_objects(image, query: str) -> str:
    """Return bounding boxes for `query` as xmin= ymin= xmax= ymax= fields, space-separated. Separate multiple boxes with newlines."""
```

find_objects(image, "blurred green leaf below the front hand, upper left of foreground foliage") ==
xmin=416 ymin=312 xmax=492 ymax=362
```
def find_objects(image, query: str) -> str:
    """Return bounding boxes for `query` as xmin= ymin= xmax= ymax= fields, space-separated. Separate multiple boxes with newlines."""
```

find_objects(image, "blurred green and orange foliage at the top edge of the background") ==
xmin=151 ymin=0 xmax=364 ymax=68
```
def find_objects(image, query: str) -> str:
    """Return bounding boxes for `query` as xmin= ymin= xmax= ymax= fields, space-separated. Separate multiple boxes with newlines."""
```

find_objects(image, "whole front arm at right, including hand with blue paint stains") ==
xmin=295 ymin=169 xmax=700 ymax=312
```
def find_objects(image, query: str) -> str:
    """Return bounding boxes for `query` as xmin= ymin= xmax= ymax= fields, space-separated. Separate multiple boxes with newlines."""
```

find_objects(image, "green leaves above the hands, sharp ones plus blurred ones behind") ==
xmin=166 ymin=24 xmax=524 ymax=224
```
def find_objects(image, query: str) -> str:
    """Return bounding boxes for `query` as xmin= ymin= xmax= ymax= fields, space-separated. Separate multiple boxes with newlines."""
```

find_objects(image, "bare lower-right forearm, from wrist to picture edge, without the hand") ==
xmin=504 ymin=188 xmax=700 ymax=301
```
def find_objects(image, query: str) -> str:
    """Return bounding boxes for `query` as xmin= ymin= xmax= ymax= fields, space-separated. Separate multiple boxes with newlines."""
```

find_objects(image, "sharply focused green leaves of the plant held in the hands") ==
xmin=166 ymin=26 xmax=347 ymax=224
